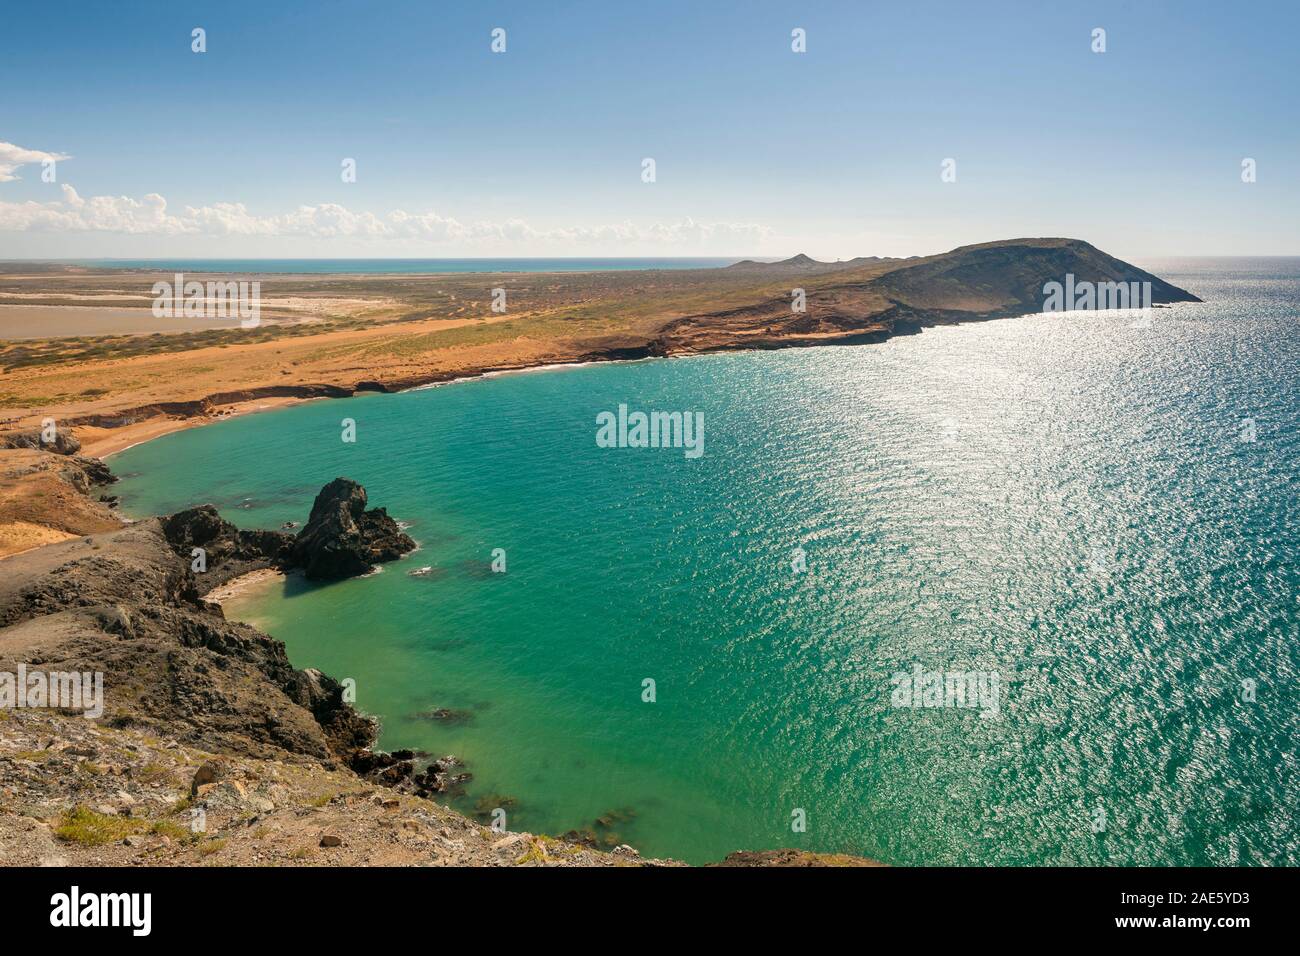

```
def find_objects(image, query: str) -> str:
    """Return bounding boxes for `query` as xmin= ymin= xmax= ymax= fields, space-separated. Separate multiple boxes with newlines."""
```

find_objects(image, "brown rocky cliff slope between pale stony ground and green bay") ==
xmin=0 ymin=519 xmax=376 ymax=765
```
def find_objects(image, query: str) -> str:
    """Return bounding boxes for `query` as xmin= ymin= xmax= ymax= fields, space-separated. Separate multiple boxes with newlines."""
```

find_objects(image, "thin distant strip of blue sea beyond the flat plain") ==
xmin=65 ymin=256 xmax=740 ymax=274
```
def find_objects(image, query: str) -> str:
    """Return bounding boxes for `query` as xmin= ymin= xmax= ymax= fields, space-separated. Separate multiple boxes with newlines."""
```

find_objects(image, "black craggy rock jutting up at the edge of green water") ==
xmin=289 ymin=477 xmax=415 ymax=580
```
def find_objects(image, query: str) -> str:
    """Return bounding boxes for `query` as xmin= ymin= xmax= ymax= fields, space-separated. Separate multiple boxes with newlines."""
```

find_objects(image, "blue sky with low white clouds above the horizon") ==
xmin=0 ymin=0 xmax=1300 ymax=259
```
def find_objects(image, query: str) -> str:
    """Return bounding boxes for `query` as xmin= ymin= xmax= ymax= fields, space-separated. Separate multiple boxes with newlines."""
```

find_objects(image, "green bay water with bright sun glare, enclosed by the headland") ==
xmin=109 ymin=260 xmax=1300 ymax=865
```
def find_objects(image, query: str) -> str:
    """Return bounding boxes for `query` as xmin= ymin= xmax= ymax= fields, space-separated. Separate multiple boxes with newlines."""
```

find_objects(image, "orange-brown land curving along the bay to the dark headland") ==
xmin=5 ymin=238 xmax=1200 ymax=457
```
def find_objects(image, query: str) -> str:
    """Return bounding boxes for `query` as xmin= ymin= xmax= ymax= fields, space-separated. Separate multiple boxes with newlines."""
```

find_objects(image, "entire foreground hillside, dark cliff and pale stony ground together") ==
xmin=0 ymin=494 xmax=670 ymax=865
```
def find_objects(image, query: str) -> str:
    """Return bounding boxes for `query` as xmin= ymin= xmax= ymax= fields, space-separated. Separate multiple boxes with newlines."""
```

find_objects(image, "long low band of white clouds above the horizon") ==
xmin=0 ymin=180 xmax=772 ymax=245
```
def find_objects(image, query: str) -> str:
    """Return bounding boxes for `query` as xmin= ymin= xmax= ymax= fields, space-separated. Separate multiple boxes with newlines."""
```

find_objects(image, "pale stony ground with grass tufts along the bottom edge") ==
xmin=0 ymin=710 xmax=655 ymax=866
